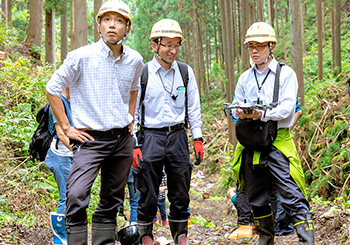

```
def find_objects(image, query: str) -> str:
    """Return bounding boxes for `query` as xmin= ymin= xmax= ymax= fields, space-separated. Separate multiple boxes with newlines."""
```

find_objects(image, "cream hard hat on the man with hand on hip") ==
xmin=96 ymin=0 xmax=132 ymax=26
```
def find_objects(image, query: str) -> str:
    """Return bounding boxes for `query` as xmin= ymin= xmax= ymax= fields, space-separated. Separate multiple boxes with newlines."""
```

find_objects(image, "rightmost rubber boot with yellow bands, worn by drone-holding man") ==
xmin=292 ymin=212 xmax=315 ymax=245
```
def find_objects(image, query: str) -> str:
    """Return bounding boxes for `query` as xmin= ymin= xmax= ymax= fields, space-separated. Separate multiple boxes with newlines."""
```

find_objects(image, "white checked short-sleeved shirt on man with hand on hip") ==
xmin=46 ymin=39 xmax=143 ymax=131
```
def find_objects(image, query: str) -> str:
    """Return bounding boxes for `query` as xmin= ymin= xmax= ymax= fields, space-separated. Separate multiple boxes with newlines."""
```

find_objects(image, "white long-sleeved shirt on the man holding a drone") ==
xmin=232 ymin=59 xmax=298 ymax=128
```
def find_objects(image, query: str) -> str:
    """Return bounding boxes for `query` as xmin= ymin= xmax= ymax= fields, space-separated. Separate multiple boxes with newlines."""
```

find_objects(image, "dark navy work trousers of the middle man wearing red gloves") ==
xmin=135 ymin=129 xmax=192 ymax=223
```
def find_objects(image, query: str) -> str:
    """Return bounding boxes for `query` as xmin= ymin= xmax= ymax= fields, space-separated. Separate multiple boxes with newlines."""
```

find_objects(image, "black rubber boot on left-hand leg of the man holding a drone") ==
xmin=254 ymin=213 xmax=275 ymax=245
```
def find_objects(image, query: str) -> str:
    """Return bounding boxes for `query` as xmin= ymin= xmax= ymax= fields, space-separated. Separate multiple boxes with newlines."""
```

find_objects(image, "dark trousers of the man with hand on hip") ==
xmin=66 ymin=127 xmax=134 ymax=225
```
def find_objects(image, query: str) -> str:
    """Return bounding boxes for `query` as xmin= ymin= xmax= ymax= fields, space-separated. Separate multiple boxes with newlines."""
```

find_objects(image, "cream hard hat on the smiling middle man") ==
xmin=149 ymin=19 xmax=185 ymax=41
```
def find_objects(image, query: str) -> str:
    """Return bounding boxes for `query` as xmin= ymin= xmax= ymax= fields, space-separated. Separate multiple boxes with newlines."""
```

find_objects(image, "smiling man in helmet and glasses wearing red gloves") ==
xmin=133 ymin=19 xmax=203 ymax=245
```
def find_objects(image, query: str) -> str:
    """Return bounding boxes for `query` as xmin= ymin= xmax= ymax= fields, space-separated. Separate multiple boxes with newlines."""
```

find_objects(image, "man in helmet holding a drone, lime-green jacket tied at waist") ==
xmin=233 ymin=22 xmax=314 ymax=244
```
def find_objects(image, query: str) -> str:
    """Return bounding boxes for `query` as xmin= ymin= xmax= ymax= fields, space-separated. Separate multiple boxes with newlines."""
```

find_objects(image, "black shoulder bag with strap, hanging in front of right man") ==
xmin=236 ymin=63 xmax=284 ymax=151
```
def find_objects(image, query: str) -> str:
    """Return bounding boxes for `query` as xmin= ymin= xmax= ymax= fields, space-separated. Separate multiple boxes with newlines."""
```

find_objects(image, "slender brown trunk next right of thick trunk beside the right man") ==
xmin=316 ymin=0 xmax=323 ymax=81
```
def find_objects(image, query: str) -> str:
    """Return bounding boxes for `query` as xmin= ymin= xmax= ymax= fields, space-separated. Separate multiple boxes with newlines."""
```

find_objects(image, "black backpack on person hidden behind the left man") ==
xmin=29 ymin=103 xmax=54 ymax=161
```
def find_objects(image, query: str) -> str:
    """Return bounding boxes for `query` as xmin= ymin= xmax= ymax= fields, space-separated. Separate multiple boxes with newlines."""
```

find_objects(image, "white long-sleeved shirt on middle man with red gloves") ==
xmin=135 ymin=57 xmax=202 ymax=139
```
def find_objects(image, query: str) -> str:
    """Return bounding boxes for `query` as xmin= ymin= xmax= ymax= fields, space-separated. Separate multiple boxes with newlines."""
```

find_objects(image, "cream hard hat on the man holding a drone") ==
xmin=244 ymin=22 xmax=277 ymax=44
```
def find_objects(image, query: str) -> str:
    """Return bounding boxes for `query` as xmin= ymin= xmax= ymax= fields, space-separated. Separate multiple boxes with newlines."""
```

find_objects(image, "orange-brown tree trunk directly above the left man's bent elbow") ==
xmin=45 ymin=9 xmax=56 ymax=70
